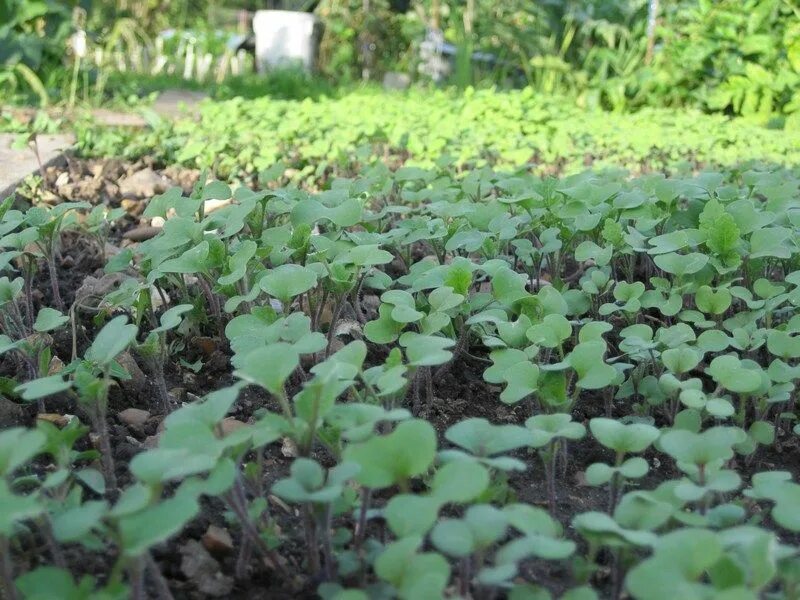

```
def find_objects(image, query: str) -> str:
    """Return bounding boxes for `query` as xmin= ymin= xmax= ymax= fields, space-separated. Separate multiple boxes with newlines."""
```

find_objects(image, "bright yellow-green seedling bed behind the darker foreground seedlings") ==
xmin=72 ymin=89 xmax=800 ymax=180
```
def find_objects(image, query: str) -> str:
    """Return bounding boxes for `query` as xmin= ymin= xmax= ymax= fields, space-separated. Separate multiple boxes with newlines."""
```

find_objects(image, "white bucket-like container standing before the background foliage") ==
xmin=253 ymin=10 xmax=317 ymax=73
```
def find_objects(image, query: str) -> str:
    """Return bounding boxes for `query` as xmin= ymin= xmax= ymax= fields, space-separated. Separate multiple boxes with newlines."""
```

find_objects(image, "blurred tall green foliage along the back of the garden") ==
xmin=0 ymin=0 xmax=800 ymax=125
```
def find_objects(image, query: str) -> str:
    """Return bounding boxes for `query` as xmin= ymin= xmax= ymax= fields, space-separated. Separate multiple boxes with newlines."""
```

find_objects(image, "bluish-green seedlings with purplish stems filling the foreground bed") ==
xmin=0 ymin=161 xmax=800 ymax=600
